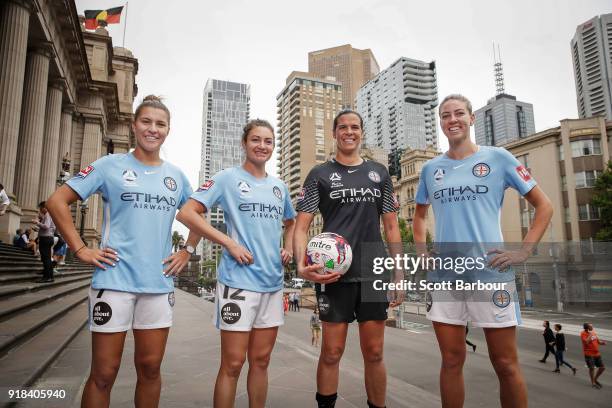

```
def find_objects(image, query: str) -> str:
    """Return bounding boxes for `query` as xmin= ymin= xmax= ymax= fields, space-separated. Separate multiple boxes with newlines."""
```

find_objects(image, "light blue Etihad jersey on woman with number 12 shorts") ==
xmin=191 ymin=166 xmax=295 ymax=292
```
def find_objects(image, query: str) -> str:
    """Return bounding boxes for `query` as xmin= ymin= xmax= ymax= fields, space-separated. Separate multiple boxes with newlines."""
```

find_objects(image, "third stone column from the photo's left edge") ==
xmin=38 ymin=81 xmax=64 ymax=201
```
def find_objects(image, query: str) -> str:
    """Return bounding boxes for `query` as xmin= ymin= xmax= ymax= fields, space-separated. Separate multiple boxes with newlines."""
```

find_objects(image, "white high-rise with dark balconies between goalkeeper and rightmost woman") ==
xmin=355 ymin=57 xmax=438 ymax=152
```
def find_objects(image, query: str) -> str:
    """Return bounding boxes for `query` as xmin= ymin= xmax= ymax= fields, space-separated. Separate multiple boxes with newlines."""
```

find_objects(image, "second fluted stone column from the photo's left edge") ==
xmin=14 ymin=45 xmax=52 ymax=226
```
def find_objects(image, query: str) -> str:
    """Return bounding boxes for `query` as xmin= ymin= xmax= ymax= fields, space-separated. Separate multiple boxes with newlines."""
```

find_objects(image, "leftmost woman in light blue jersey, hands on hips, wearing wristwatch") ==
xmin=47 ymin=95 xmax=199 ymax=407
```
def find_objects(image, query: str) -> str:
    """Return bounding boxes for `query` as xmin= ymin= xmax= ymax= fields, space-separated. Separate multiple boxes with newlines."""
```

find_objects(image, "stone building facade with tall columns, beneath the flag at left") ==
xmin=0 ymin=0 xmax=138 ymax=244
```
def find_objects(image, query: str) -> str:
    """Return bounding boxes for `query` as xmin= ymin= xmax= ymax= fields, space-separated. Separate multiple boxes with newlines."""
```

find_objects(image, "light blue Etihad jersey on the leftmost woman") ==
xmin=66 ymin=153 xmax=192 ymax=293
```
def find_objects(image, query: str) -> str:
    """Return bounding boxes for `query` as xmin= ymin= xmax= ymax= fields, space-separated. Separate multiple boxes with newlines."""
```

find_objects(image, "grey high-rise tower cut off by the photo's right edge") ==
xmin=571 ymin=13 xmax=612 ymax=120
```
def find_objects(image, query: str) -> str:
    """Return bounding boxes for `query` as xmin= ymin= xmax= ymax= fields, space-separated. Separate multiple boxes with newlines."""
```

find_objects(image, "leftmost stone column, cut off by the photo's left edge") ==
xmin=0 ymin=0 xmax=31 ymax=195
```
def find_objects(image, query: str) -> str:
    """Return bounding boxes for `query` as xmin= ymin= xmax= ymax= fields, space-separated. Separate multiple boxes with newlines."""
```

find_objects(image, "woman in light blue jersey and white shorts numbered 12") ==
xmin=177 ymin=119 xmax=295 ymax=407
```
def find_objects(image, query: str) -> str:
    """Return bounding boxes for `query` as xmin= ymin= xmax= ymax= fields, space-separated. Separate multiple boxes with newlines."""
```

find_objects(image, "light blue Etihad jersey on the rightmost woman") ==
xmin=416 ymin=146 xmax=536 ymax=282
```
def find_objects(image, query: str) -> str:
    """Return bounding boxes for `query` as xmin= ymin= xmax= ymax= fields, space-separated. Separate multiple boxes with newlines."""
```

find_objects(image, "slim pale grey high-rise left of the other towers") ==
xmin=199 ymin=79 xmax=251 ymax=259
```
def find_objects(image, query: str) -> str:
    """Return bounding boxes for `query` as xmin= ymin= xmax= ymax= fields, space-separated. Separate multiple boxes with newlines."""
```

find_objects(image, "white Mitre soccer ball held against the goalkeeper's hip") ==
xmin=306 ymin=232 xmax=353 ymax=275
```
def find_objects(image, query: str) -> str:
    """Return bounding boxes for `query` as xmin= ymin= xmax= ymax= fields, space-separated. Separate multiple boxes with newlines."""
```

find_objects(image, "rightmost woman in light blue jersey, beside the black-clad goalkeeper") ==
xmin=413 ymin=95 xmax=552 ymax=408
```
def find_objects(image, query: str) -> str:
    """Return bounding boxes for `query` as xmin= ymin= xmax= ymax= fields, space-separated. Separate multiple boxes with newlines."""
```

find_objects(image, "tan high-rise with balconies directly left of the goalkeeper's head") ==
xmin=276 ymin=71 xmax=342 ymax=233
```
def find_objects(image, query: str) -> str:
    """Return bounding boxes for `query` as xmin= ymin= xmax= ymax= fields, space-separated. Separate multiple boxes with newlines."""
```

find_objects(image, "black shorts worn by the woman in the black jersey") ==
xmin=315 ymin=282 xmax=389 ymax=323
